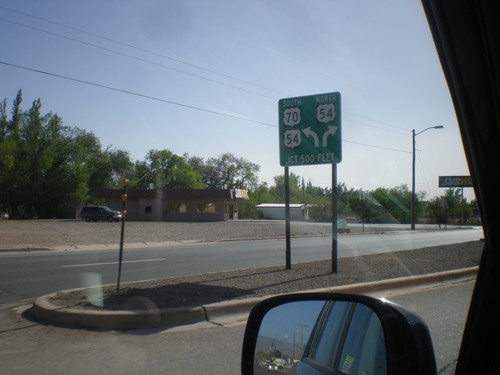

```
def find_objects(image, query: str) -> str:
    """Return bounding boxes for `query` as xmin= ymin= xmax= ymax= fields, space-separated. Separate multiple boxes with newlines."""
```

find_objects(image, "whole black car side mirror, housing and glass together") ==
xmin=241 ymin=293 xmax=437 ymax=375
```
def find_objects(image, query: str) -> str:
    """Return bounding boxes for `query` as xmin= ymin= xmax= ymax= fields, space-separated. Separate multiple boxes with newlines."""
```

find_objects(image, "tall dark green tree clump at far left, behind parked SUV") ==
xmin=0 ymin=90 xmax=132 ymax=217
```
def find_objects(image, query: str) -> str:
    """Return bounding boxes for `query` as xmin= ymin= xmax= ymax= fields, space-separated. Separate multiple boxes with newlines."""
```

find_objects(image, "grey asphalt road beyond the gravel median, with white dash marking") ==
xmin=0 ymin=229 xmax=482 ymax=302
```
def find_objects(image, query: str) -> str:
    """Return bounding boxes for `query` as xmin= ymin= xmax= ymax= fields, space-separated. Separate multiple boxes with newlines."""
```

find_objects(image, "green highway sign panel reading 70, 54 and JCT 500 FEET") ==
xmin=278 ymin=92 xmax=342 ymax=167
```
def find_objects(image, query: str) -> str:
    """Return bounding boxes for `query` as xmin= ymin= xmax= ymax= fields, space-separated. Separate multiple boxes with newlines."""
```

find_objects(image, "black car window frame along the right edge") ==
xmin=422 ymin=0 xmax=500 ymax=374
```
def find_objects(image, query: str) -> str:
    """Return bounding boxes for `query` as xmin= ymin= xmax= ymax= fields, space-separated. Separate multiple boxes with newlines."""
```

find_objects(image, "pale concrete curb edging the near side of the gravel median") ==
xmin=27 ymin=267 xmax=478 ymax=330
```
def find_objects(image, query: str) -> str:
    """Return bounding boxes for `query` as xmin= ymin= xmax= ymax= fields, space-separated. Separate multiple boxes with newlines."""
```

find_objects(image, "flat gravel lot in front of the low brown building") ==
xmin=0 ymin=220 xmax=332 ymax=248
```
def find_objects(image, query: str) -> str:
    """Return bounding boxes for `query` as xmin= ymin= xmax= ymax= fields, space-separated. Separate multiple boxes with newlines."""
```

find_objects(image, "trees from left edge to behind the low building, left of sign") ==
xmin=0 ymin=90 xmax=260 ymax=218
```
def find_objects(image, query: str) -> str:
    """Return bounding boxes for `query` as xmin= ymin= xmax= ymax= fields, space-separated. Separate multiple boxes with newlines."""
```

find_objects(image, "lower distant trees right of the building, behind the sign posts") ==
xmin=244 ymin=173 xmax=474 ymax=225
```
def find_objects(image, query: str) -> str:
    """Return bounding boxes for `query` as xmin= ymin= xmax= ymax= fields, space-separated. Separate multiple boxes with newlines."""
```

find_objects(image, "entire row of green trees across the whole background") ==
xmin=0 ymin=90 xmax=472 ymax=223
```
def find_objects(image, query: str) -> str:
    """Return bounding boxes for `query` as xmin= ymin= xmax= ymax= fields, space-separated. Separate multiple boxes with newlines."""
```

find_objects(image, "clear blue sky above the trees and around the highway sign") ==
xmin=0 ymin=0 xmax=473 ymax=203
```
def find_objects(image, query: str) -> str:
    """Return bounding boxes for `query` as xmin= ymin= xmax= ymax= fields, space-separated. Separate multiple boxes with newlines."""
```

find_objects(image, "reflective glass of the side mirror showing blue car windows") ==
xmin=254 ymin=301 xmax=387 ymax=374
